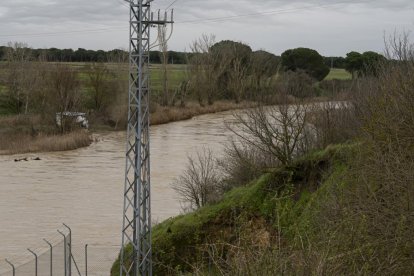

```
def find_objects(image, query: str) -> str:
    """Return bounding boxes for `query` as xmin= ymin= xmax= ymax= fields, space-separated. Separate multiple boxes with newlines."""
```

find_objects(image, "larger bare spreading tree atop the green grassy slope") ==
xmin=228 ymin=94 xmax=312 ymax=165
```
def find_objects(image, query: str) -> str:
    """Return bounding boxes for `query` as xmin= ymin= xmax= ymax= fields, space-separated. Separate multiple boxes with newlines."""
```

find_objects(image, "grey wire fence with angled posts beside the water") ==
xmin=0 ymin=225 xmax=120 ymax=276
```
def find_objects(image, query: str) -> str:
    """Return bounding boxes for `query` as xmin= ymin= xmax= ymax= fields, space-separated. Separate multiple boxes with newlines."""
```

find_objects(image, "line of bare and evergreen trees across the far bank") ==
xmin=0 ymin=38 xmax=385 ymax=133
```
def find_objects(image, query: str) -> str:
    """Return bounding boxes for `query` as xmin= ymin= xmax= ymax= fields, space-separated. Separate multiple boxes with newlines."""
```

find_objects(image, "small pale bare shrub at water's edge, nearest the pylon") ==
xmin=173 ymin=149 xmax=220 ymax=210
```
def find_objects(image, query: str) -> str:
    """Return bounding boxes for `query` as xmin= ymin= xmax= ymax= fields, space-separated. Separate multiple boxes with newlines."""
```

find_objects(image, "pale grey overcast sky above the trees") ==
xmin=0 ymin=0 xmax=414 ymax=56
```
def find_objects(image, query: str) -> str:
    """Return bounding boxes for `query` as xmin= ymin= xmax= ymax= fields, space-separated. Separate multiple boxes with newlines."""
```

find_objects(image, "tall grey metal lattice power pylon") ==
xmin=120 ymin=0 xmax=172 ymax=276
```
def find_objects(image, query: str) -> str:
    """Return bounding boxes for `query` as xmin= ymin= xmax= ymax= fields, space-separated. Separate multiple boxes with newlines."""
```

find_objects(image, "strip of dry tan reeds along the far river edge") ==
xmin=0 ymin=101 xmax=256 ymax=155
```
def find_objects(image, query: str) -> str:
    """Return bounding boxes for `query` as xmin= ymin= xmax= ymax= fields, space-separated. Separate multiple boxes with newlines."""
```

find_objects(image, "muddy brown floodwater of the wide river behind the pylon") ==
xmin=0 ymin=109 xmax=238 ymax=275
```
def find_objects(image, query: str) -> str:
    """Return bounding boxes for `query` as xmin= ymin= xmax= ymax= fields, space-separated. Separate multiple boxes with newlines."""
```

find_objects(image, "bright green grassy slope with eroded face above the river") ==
xmin=112 ymin=143 xmax=352 ymax=275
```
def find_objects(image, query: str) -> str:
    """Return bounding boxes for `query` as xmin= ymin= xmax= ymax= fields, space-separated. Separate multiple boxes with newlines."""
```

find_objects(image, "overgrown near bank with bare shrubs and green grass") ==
xmin=112 ymin=33 xmax=414 ymax=275
